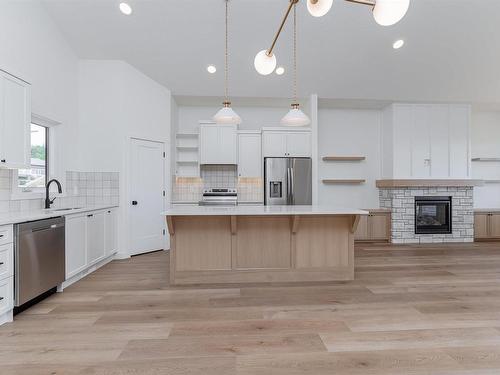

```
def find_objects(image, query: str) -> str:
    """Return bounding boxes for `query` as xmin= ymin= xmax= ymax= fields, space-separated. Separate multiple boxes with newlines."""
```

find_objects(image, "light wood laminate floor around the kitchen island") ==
xmin=0 ymin=243 xmax=500 ymax=375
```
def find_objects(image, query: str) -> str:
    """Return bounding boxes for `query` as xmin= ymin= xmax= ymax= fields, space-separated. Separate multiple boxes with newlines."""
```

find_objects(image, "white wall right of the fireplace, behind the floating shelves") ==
xmin=471 ymin=111 xmax=500 ymax=208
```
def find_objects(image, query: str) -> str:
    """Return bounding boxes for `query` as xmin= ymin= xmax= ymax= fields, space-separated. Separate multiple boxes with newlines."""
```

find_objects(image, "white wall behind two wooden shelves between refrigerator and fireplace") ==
xmin=318 ymin=109 xmax=382 ymax=208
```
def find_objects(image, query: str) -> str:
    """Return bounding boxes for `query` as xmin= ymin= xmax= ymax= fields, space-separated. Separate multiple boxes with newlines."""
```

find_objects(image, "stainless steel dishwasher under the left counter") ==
xmin=14 ymin=217 xmax=66 ymax=307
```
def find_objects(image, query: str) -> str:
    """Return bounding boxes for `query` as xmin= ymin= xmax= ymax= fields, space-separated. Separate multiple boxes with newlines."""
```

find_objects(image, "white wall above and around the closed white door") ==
xmin=78 ymin=60 xmax=171 ymax=256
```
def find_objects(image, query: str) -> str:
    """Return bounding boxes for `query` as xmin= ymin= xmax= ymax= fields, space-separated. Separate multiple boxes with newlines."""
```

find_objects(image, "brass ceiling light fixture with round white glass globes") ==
xmin=254 ymin=0 xmax=410 ymax=75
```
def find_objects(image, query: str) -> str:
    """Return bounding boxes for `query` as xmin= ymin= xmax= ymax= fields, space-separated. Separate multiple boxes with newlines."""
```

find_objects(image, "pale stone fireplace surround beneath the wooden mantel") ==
xmin=379 ymin=184 xmax=474 ymax=244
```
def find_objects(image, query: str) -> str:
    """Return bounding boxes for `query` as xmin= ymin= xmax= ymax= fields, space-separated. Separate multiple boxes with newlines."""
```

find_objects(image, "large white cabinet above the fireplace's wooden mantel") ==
xmin=382 ymin=104 xmax=470 ymax=179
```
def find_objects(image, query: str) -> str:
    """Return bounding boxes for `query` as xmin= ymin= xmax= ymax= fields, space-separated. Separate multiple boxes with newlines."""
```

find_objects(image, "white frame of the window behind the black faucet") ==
xmin=10 ymin=113 xmax=60 ymax=200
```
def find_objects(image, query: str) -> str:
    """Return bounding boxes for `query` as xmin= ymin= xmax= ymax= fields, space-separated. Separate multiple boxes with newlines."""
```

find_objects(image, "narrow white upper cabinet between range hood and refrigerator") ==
xmin=238 ymin=131 xmax=263 ymax=177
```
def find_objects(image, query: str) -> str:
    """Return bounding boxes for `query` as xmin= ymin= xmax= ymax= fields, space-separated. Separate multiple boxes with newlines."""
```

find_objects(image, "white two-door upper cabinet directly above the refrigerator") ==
xmin=262 ymin=129 xmax=311 ymax=157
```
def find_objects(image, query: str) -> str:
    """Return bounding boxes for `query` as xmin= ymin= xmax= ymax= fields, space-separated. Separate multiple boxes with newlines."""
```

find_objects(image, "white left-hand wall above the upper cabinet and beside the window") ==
xmin=0 ymin=1 xmax=78 ymax=178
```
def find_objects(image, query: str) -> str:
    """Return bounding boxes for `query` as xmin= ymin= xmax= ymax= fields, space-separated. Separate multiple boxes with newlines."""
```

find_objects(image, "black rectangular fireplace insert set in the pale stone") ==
xmin=415 ymin=197 xmax=452 ymax=234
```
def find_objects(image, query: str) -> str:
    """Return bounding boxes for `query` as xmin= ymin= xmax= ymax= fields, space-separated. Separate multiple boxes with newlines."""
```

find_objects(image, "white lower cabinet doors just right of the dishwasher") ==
xmin=66 ymin=209 xmax=118 ymax=280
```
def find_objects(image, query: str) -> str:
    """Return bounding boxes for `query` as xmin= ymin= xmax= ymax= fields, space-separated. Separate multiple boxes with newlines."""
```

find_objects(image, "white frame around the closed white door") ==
xmin=121 ymin=136 xmax=171 ymax=258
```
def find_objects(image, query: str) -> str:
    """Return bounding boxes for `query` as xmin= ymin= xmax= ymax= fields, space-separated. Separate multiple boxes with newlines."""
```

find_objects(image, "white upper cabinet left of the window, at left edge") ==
xmin=0 ymin=71 xmax=31 ymax=169
